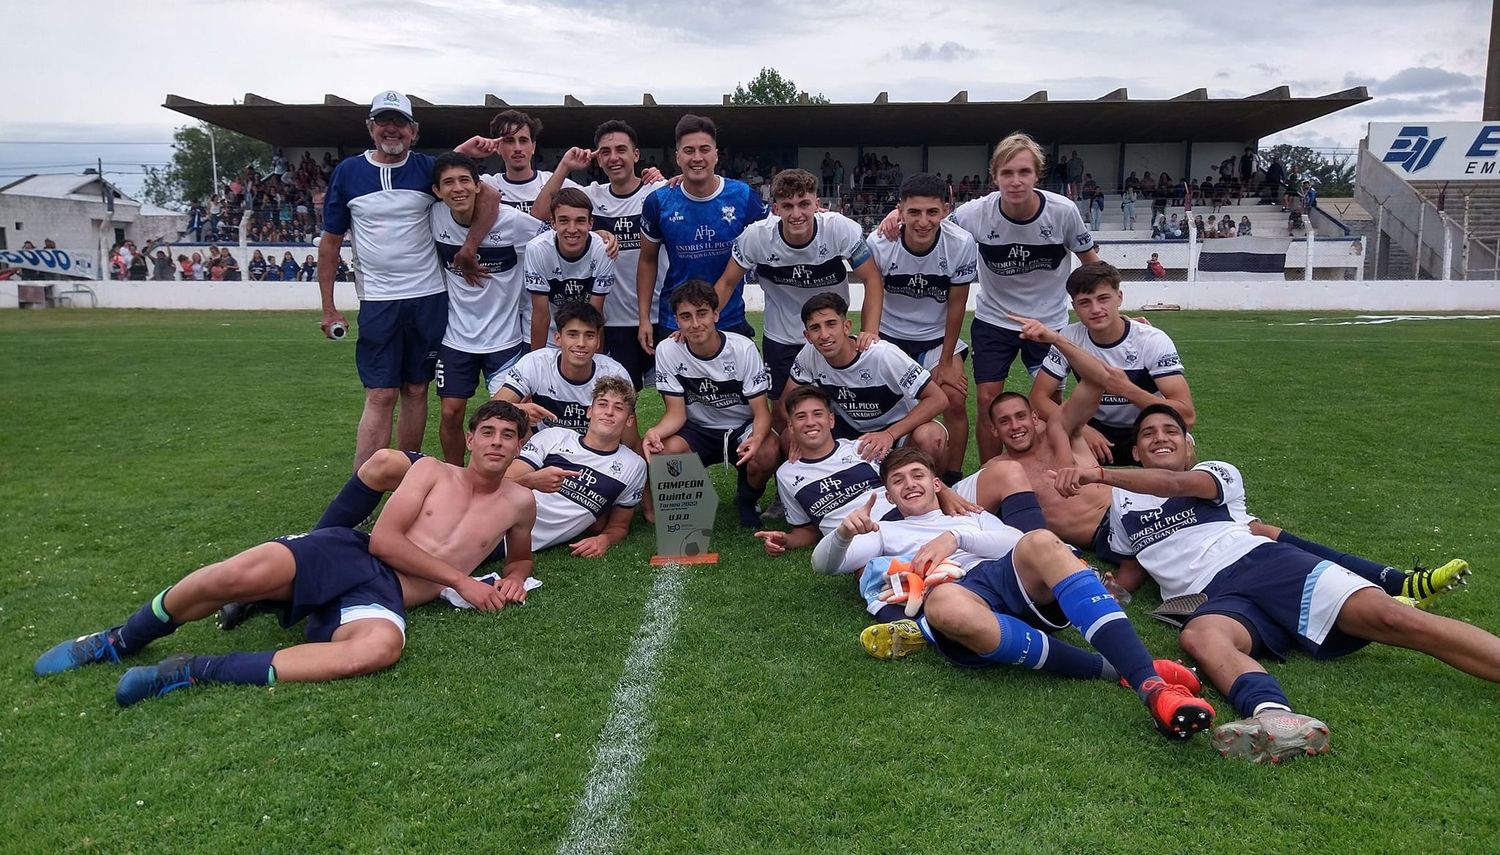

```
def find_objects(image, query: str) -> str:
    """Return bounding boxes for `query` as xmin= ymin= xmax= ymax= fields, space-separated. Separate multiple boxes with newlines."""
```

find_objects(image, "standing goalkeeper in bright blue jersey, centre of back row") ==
xmin=636 ymin=114 xmax=767 ymax=354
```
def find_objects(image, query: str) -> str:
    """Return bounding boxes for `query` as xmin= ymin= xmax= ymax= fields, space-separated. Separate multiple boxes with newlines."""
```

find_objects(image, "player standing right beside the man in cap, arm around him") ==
xmin=431 ymin=152 xmax=546 ymax=467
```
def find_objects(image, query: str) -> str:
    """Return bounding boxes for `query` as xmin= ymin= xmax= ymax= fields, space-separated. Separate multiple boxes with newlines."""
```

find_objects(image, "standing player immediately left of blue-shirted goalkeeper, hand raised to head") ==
xmin=533 ymin=119 xmax=666 ymax=390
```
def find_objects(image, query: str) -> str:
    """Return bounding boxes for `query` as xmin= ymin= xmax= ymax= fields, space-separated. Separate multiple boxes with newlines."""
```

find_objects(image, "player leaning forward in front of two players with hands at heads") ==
xmin=525 ymin=188 xmax=615 ymax=350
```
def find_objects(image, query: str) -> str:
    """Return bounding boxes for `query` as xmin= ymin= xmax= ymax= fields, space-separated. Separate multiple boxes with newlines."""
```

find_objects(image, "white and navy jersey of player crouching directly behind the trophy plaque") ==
xmin=657 ymin=332 xmax=771 ymax=431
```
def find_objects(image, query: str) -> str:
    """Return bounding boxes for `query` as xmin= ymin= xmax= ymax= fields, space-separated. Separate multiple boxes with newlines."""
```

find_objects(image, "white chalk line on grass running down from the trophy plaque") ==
xmin=558 ymin=564 xmax=687 ymax=855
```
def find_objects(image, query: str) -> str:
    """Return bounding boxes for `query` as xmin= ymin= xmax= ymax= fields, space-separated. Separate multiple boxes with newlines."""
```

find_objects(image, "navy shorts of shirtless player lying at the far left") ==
xmin=275 ymin=528 xmax=407 ymax=642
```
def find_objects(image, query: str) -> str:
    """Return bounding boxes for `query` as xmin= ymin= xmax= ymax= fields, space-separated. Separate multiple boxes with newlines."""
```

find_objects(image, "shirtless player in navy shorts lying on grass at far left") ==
xmin=35 ymin=402 xmax=536 ymax=707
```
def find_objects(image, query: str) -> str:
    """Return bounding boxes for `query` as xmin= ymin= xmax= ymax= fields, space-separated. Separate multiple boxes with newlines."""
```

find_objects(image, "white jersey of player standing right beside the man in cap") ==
xmin=431 ymin=203 xmax=546 ymax=354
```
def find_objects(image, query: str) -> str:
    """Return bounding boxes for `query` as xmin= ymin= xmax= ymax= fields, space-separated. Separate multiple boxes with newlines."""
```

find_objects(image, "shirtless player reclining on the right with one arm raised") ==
xmin=996 ymin=317 xmax=1469 ymax=608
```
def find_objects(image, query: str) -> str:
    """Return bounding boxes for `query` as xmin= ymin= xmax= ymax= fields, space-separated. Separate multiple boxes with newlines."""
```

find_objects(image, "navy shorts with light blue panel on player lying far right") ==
xmin=1188 ymin=543 xmax=1376 ymax=659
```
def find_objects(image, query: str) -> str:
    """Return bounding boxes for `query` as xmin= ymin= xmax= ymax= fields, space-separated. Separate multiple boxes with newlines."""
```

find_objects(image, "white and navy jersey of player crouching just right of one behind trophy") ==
xmin=792 ymin=342 xmax=932 ymax=434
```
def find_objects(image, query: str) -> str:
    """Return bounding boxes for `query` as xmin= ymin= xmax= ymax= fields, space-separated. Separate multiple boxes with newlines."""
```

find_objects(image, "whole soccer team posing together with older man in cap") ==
xmin=35 ymin=92 xmax=1500 ymax=762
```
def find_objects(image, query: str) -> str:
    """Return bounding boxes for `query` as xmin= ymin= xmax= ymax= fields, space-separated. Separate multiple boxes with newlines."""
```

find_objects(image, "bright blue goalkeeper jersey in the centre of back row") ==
xmin=641 ymin=179 xmax=767 ymax=330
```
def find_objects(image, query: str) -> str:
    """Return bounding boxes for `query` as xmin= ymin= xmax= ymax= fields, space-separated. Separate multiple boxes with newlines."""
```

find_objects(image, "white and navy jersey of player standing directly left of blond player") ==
xmin=870 ymin=221 xmax=980 ymax=347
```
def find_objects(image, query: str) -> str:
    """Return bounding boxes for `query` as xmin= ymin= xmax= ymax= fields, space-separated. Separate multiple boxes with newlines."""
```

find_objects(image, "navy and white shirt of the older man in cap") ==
xmin=323 ymin=152 xmax=446 ymax=300
